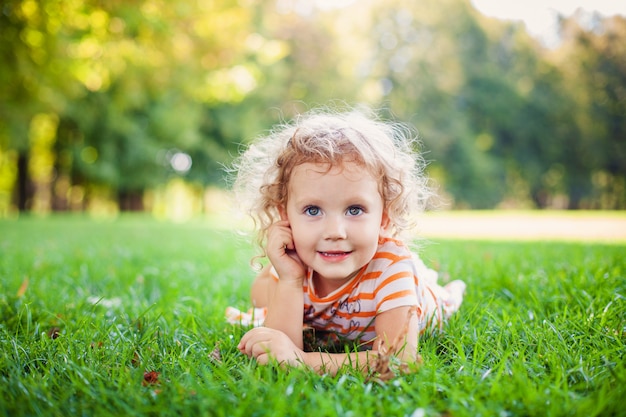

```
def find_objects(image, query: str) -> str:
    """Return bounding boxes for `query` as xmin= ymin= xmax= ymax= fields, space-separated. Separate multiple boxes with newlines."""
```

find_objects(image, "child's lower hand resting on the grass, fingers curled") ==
xmin=237 ymin=327 xmax=305 ymax=366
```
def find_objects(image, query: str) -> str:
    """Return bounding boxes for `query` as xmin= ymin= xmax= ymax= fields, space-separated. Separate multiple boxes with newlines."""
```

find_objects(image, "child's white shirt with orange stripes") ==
xmin=272 ymin=238 xmax=441 ymax=345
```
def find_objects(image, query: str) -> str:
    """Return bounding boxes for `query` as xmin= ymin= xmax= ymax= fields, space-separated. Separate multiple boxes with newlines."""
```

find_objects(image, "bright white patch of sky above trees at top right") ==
xmin=471 ymin=0 xmax=626 ymax=43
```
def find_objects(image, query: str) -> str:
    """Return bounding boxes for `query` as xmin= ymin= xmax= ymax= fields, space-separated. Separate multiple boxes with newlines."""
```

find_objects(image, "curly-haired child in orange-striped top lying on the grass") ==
xmin=229 ymin=107 xmax=465 ymax=374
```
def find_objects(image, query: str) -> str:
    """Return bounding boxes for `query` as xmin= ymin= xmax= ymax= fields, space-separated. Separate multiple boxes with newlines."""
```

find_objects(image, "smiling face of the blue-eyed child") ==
xmin=282 ymin=162 xmax=386 ymax=287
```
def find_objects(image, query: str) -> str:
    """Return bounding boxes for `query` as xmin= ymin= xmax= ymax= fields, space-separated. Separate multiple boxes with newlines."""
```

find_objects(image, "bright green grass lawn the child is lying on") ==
xmin=0 ymin=216 xmax=626 ymax=416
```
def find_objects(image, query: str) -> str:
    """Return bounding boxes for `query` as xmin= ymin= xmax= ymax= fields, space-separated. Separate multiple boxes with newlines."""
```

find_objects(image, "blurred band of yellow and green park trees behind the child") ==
xmin=0 ymin=0 xmax=626 ymax=219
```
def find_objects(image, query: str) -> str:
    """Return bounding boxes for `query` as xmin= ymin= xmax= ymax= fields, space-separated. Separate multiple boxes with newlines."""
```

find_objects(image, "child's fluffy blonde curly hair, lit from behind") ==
xmin=232 ymin=106 xmax=431 ymax=256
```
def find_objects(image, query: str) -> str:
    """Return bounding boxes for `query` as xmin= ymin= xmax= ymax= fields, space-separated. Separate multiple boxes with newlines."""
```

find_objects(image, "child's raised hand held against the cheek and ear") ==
xmin=266 ymin=220 xmax=306 ymax=283
